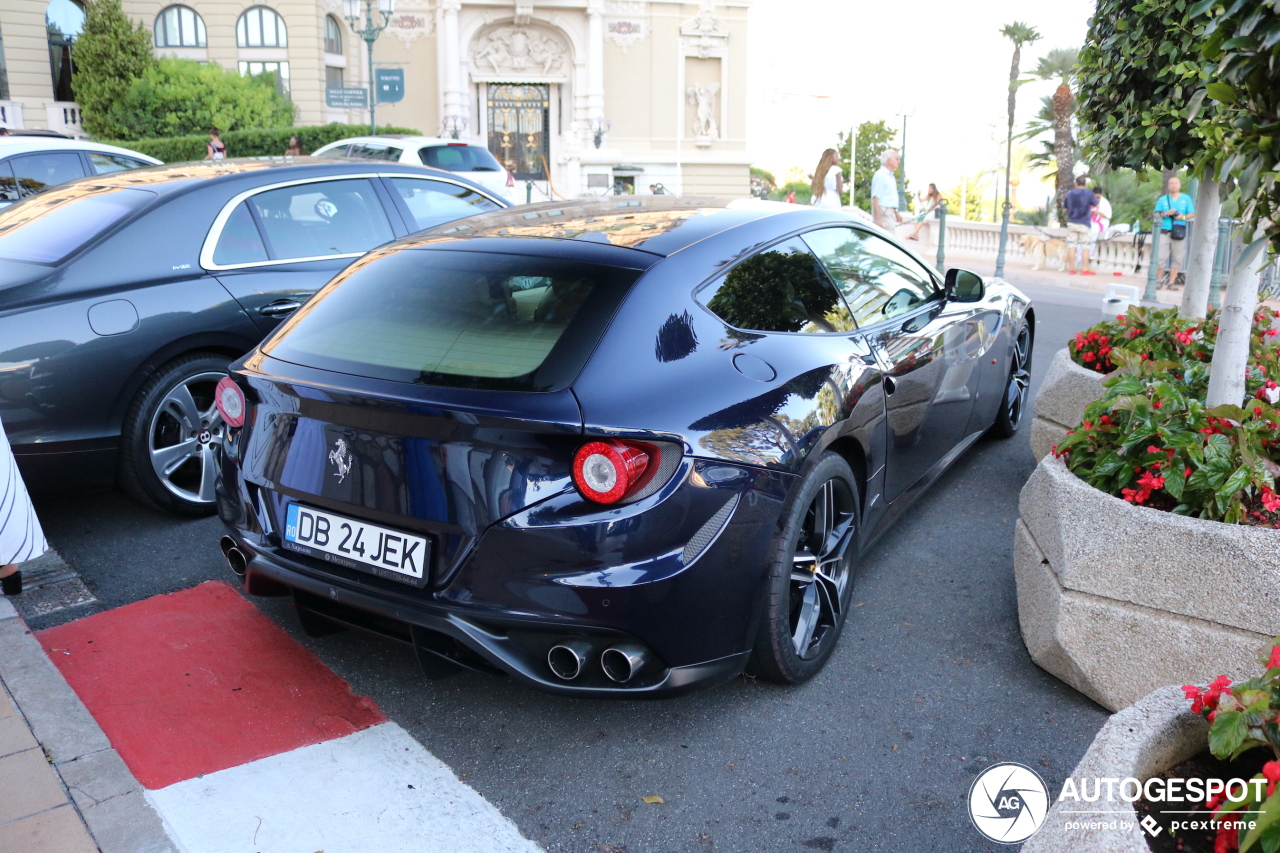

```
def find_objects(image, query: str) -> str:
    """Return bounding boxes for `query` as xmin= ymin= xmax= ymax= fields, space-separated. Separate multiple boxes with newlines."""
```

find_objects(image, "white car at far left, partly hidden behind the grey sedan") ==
xmin=0 ymin=133 xmax=163 ymax=207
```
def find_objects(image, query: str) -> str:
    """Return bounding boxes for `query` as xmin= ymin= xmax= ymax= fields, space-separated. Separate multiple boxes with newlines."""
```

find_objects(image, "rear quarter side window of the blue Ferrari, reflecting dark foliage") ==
xmin=696 ymin=238 xmax=854 ymax=333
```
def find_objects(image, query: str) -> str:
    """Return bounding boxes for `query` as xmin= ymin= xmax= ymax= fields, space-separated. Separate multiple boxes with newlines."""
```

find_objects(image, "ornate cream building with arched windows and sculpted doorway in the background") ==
xmin=0 ymin=0 xmax=751 ymax=199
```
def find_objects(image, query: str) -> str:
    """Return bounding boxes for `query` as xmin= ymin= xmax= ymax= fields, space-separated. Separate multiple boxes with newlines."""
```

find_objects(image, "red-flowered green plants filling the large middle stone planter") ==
xmin=1053 ymin=309 xmax=1280 ymax=528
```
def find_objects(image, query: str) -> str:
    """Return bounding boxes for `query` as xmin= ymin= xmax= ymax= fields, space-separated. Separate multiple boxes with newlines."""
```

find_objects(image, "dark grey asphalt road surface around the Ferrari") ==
xmin=33 ymin=280 xmax=1106 ymax=853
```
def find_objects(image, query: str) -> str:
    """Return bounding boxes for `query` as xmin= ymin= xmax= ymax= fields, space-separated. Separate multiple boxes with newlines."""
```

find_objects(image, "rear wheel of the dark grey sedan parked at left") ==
xmin=119 ymin=352 xmax=230 ymax=517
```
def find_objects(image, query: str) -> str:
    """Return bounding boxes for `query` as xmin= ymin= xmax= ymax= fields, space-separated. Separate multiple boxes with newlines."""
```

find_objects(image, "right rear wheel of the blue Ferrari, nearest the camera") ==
xmin=750 ymin=452 xmax=861 ymax=684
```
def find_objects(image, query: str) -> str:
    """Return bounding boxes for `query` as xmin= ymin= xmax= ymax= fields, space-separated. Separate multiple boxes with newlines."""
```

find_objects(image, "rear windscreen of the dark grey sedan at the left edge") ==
xmin=0 ymin=186 xmax=156 ymax=264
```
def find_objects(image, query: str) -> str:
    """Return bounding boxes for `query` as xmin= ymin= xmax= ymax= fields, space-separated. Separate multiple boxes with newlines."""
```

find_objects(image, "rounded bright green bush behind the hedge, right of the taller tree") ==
xmin=108 ymin=59 xmax=293 ymax=141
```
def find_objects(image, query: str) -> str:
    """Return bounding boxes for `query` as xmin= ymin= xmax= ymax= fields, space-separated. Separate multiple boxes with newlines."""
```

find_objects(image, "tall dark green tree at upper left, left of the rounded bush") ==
xmin=76 ymin=0 xmax=156 ymax=138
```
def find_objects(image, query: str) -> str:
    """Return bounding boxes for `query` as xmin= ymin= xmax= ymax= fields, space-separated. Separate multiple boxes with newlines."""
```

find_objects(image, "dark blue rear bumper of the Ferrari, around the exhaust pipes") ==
xmin=219 ymin=460 xmax=792 ymax=698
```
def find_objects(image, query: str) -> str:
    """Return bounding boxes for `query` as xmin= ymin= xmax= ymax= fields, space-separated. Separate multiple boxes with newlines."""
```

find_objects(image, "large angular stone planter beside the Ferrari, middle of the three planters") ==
xmin=1014 ymin=455 xmax=1280 ymax=711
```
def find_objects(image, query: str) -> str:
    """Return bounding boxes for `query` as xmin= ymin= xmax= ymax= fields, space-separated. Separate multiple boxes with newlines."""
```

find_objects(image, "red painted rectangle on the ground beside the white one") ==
xmin=37 ymin=583 xmax=385 ymax=790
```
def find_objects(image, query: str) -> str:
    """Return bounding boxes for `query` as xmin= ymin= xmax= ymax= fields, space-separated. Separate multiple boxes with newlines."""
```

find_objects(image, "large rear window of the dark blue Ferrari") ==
xmin=264 ymin=250 xmax=639 ymax=391
